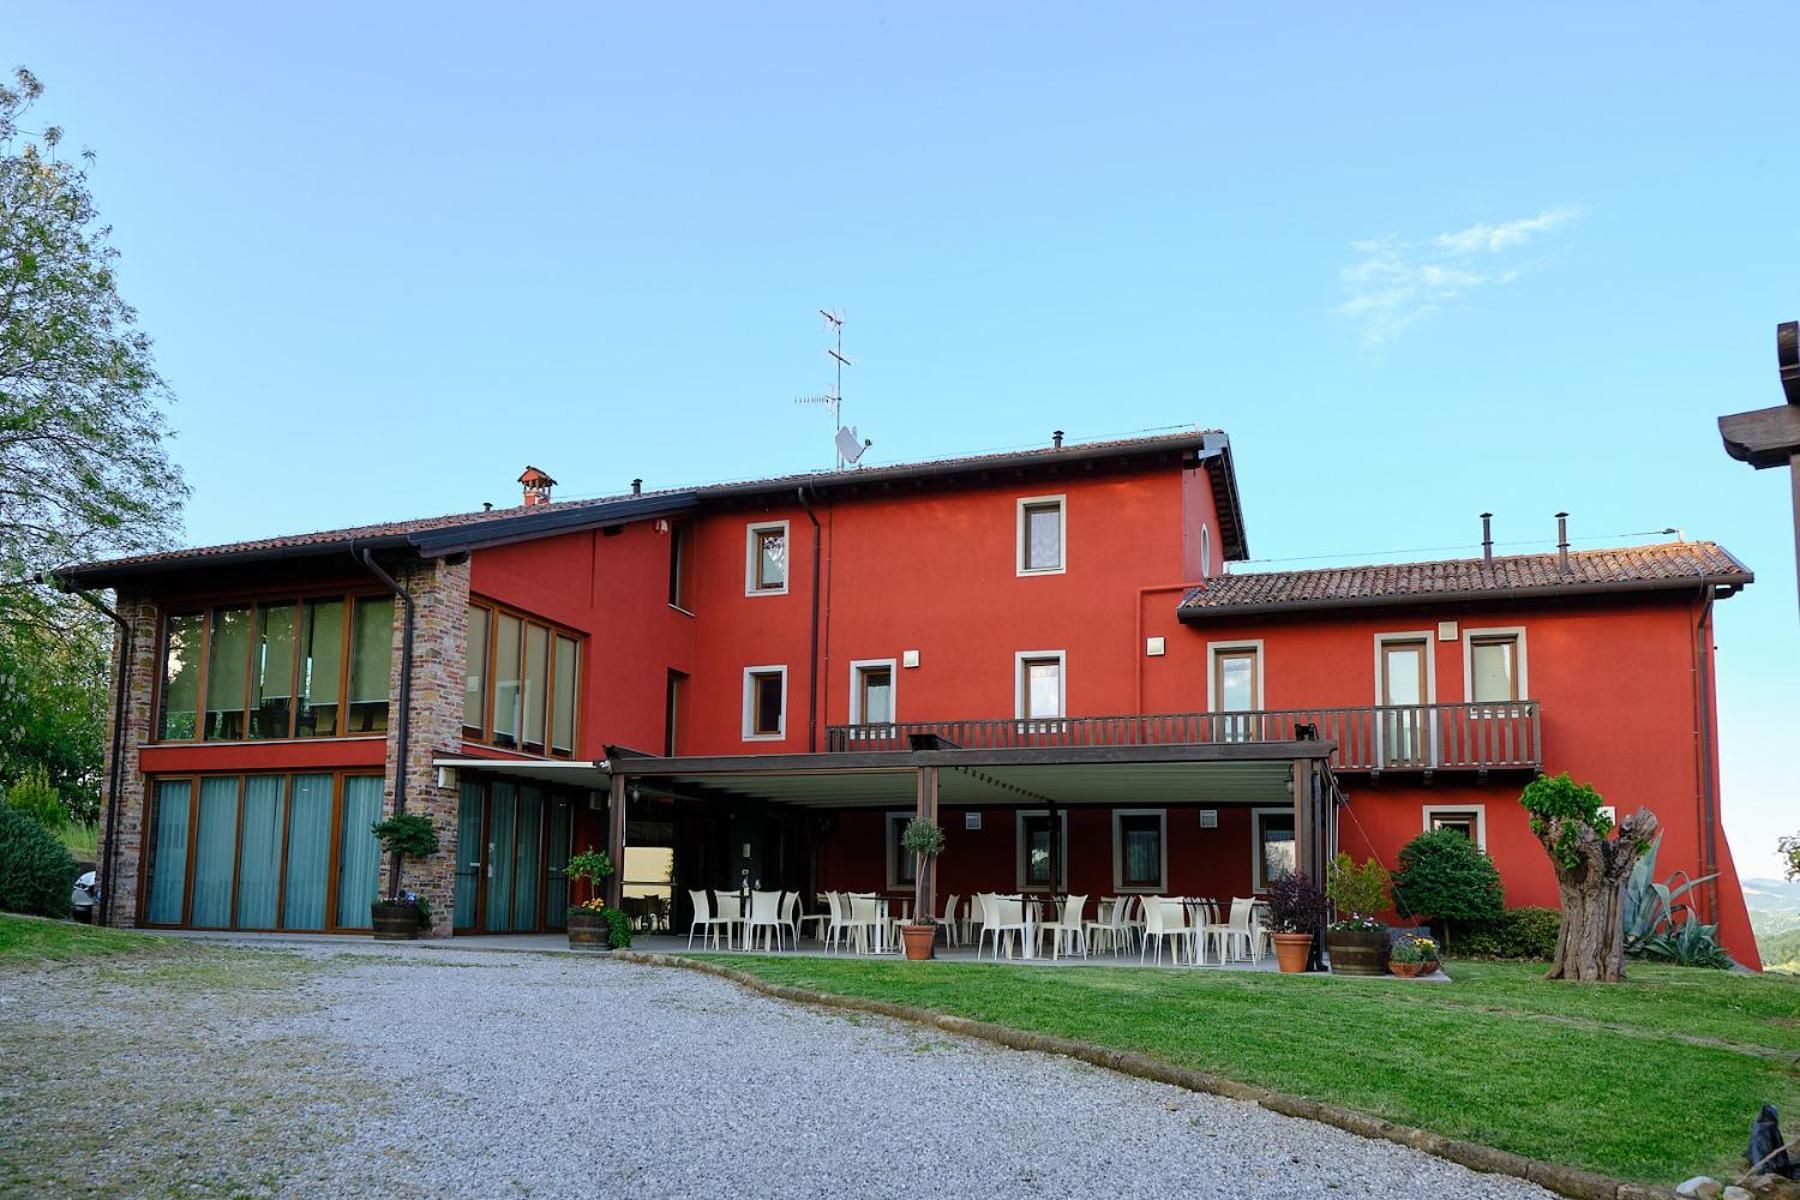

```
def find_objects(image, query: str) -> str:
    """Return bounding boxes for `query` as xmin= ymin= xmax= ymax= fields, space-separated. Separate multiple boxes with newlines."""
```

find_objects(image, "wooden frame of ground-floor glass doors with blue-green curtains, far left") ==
xmin=137 ymin=766 xmax=387 ymax=937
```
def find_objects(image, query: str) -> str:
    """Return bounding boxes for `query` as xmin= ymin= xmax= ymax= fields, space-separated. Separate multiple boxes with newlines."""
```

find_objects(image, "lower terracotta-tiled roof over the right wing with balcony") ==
xmin=1177 ymin=542 xmax=1755 ymax=621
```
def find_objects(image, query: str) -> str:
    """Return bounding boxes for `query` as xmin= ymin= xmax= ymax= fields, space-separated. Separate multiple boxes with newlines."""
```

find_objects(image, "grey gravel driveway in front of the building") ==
xmin=0 ymin=943 xmax=1550 ymax=1200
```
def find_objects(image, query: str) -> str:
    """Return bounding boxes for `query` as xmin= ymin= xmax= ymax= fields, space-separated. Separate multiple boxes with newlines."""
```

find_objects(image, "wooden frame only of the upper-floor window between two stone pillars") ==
xmin=149 ymin=588 xmax=394 ymax=747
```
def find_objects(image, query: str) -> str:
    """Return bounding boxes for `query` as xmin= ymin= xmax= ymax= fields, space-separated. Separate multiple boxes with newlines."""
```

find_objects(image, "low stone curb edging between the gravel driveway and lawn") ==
xmin=612 ymin=950 xmax=1676 ymax=1200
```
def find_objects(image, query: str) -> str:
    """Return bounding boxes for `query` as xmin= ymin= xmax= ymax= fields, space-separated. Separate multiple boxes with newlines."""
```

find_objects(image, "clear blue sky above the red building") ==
xmin=17 ymin=4 xmax=1800 ymax=874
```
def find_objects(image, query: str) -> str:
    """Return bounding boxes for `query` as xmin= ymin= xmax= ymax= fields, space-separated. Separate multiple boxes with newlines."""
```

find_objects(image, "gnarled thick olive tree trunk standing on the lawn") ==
xmin=1537 ymin=808 xmax=1656 ymax=984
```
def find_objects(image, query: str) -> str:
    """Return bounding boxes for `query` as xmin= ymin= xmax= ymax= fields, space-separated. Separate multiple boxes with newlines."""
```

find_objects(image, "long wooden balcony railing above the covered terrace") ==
xmin=824 ymin=700 xmax=1544 ymax=775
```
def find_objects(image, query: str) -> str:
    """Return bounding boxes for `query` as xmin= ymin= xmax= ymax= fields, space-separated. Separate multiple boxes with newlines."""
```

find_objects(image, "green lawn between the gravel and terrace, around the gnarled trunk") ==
xmin=695 ymin=955 xmax=1800 ymax=1184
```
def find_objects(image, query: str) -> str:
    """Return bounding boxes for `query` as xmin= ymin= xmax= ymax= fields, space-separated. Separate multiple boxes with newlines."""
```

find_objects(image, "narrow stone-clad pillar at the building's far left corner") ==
xmin=99 ymin=592 xmax=160 ymax=928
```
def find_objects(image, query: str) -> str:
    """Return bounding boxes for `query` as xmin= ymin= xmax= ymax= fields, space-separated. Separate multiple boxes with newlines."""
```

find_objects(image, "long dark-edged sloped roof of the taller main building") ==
xmin=50 ymin=428 xmax=1247 ymax=588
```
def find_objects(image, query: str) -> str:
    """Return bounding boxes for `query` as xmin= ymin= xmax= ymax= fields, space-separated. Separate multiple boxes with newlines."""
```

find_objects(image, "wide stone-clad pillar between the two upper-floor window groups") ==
xmin=382 ymin=560 xmax=468 ymax=937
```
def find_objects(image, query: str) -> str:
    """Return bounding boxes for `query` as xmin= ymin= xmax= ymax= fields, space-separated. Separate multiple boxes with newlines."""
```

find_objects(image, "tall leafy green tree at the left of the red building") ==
xmin=0 ymin=68 xmax=187 ymax=820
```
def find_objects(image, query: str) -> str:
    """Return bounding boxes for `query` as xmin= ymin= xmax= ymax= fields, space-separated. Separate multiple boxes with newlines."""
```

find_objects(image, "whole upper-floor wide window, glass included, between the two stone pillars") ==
xmin=157 ymin=596 xmax=383 ymax=741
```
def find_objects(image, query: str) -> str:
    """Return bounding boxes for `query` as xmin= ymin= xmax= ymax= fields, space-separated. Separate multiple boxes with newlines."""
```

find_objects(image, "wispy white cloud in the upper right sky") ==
xmin=1337 ymin=209 xmax=1580 ymax=345
